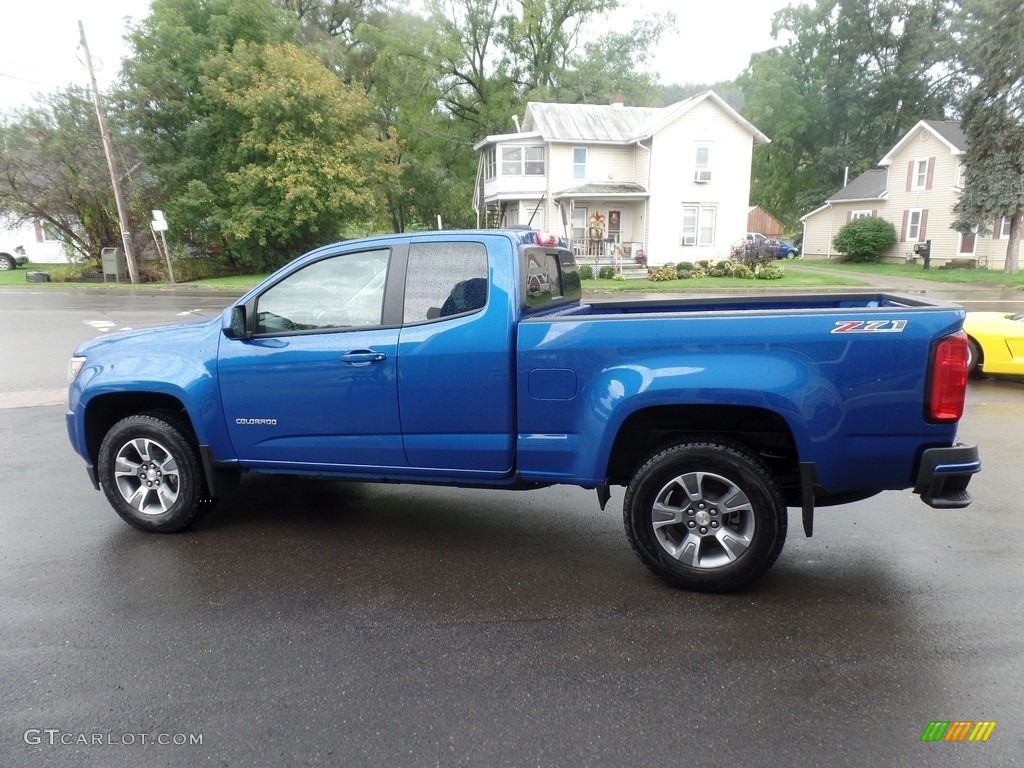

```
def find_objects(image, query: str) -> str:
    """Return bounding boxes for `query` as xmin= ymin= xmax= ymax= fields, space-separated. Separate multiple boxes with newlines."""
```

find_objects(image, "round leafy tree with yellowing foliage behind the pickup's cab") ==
xmin=188 ymin=41 xmax=396 ymax=268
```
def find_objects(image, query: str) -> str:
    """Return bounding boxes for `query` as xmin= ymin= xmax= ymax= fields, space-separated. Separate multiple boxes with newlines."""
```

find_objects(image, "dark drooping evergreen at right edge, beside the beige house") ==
xmin=954 ymin=0 xmax=1024 ymax=274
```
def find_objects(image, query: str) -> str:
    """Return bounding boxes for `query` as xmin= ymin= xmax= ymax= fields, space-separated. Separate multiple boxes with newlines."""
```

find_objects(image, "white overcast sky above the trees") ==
xmin=0 ymin=0 xmax=796 ymax=110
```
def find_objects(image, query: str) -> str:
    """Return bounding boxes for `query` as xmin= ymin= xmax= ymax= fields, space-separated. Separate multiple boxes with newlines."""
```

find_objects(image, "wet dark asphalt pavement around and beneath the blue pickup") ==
xmin=0 ymin=292 xmax=1024 ymax=767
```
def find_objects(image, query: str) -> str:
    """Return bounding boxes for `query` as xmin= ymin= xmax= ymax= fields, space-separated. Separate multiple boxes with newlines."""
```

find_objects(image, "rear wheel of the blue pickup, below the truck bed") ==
xmin=623 ymin=437 xmax=788 ymax=592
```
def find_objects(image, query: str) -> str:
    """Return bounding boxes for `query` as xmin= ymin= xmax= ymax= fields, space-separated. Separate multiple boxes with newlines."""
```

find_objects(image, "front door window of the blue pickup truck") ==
xmin=256 ymin=249 xmax=390 ymax=334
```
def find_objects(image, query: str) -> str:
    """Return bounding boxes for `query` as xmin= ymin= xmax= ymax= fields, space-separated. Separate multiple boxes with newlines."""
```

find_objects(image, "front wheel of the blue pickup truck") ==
xmin=98 ymin=411 xmax=213 ymax=534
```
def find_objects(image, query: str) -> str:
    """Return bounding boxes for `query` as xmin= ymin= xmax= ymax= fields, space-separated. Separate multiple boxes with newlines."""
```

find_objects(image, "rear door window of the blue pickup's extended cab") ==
xmin=403 ymin=243 xmax=487 ymax=325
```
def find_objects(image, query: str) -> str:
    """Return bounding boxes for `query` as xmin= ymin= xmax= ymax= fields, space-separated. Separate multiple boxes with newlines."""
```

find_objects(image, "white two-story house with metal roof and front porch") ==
xmin=473 ymin=91 xmax=768 ymax=264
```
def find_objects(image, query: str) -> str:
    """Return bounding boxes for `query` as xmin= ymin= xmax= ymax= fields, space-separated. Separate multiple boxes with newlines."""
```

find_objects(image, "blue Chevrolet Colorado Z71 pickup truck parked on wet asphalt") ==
xmin=67 ymin=230 xmax=980 ymax=592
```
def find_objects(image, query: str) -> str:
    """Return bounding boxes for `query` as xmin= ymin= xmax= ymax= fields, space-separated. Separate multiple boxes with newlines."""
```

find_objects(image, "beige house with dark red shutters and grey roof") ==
xmin=801 ymin=120 xmax=1010 ymax=269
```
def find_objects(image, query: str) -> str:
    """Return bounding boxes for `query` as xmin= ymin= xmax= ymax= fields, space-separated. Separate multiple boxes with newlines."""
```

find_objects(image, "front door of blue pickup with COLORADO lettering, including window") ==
xmin=218 ymin=249 xmax=406 ymax=469
